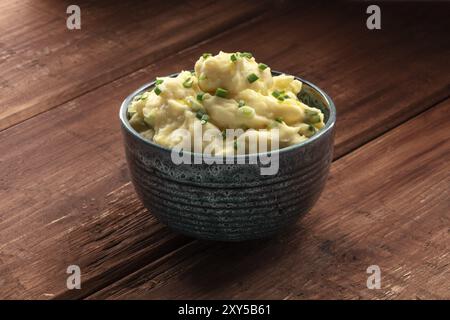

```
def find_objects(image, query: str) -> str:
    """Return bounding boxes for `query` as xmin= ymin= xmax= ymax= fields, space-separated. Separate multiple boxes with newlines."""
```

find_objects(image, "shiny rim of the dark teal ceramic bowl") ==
xmin=119 ymin=70 xmax=336 ymax=159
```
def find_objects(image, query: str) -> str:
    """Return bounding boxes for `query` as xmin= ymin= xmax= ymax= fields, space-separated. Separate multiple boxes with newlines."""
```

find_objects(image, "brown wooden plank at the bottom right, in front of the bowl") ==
xmin=90 ymin=100 xmax=450 ymax=299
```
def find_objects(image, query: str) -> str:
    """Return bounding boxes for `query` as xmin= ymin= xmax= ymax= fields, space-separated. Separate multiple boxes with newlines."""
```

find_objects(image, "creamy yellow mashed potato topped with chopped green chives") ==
xmin=128 ymin=52 xmax=324 ymax=155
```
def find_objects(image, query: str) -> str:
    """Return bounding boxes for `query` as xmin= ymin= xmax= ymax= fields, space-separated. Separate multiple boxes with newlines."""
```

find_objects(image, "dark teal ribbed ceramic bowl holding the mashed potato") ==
xmin=120 ymin=72 xmax=336 ymax=241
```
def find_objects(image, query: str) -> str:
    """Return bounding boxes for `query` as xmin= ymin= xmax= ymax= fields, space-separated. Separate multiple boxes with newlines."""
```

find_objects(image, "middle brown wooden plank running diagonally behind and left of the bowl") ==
xmin=0 ymin=4 xmax=450 ymax=298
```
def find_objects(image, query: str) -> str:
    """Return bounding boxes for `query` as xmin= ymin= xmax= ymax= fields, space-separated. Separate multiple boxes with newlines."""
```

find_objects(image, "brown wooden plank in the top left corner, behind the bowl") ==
xmin=0 ymin=0 xmax=265 ymax=130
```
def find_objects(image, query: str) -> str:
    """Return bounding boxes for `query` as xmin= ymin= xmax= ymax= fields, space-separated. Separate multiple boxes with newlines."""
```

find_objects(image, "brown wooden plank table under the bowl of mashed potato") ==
xmin=0 ymin=0 xmax=450 ymax=299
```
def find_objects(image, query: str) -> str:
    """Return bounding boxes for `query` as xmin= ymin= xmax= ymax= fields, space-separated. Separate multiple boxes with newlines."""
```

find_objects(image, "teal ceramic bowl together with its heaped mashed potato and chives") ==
xmin=119 ymin=53 xmax=336 ymax=241
